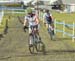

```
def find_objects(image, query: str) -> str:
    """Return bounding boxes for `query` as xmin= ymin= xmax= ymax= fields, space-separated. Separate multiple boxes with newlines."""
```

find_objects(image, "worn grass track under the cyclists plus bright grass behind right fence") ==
xmin=0 ymin=12 xmax=75 ymax=61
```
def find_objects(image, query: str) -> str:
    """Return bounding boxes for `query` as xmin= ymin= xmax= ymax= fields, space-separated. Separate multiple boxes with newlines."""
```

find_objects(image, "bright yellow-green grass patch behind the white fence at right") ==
xmin=52 ymin=12 xmax=75 ymax=23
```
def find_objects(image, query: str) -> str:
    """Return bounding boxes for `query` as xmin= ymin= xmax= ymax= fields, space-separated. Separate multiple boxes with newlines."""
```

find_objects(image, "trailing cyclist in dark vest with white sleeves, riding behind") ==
xmin=43 ymin=10 xmax=54 ymax=35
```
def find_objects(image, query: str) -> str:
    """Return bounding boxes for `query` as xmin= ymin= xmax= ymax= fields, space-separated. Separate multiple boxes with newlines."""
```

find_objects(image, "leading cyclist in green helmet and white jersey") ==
xmin=24 ymin=8 xmax=41 ymax=47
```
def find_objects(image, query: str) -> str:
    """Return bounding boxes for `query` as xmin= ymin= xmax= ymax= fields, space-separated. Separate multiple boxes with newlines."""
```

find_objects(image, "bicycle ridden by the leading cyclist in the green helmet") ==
xmin=25 ymin=26 xmax=45 ymax=54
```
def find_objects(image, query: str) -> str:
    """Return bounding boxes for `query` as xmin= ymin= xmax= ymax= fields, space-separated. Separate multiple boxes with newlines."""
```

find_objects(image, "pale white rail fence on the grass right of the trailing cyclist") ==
xmin=54 ymin=20 xmax=75 ymax=42
